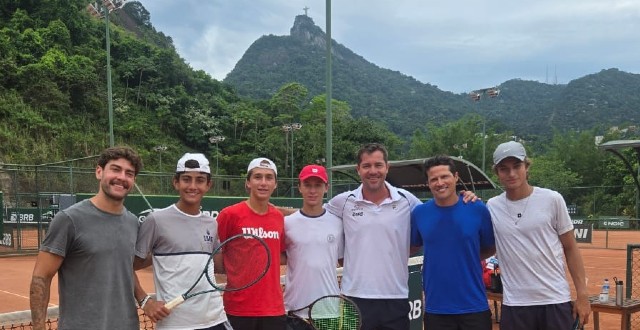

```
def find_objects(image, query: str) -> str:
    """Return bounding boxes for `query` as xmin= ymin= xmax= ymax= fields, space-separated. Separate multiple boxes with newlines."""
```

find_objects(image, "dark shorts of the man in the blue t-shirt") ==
xmin=423 ymin=310 xmax=493 ymax=330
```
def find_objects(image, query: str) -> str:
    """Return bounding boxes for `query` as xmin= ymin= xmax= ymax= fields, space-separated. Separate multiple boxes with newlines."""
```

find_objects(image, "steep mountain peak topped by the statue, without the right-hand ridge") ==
xmin=224 ymin=15 xmax=470 ymax=135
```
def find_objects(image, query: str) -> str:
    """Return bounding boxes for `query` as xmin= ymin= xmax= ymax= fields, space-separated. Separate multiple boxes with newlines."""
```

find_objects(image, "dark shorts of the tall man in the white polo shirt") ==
xmin=348 ymin=297 xmax=411 ymax=330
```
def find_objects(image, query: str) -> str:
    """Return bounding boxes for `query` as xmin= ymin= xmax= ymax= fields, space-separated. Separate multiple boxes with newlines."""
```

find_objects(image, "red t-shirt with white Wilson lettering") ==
xmin=216 ymin=202 xmax=285 ymax=316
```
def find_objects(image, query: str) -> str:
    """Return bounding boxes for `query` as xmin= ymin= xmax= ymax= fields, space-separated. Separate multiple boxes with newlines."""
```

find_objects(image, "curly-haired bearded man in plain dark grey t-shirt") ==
xmin=30 ymin=147 xmax=142 ymax=330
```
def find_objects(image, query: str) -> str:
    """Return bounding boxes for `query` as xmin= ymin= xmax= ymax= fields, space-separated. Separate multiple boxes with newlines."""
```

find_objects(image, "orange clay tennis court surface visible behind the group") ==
xmin=0 ymin=231 xmax=640 ymax=329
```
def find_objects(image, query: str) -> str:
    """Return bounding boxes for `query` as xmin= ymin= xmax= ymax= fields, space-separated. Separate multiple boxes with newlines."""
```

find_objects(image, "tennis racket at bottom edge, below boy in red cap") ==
xmin=289 ymin=295 xmax=362 ymax=330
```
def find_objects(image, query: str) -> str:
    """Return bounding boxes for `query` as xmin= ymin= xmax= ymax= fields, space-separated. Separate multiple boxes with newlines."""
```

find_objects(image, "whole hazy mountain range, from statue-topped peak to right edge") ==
xmin=224 ymin=15 xmax=640 ymax=137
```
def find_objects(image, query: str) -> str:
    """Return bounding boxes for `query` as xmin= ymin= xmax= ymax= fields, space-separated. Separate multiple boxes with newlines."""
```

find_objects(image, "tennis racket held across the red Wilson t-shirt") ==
xmin=164 ymin=234 xmax=271 ymax=309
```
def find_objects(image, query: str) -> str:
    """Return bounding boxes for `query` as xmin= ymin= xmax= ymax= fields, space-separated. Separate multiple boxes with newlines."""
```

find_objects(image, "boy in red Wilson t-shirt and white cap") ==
xmin=216 ymin=158 xmax=286 ymax=330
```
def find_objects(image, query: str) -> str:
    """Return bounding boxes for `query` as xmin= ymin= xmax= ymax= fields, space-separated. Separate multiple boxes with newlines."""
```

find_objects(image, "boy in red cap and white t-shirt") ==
xmin=283 ymin=165 xmax=344 ymax=330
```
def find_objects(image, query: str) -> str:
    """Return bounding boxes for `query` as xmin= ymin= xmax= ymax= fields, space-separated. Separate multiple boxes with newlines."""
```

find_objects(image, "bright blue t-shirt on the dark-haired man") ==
xmin=411 ymin=198 xmax=495 ymax=314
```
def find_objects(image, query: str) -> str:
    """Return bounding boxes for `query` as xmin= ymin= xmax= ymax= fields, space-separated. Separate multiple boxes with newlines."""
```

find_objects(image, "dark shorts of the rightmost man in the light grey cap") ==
xmin=500 ymin=302 xmax=574 ymax=330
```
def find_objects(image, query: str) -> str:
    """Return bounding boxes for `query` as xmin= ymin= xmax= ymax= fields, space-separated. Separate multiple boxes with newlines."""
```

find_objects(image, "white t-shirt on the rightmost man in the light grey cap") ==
xmin=487 ymin=187 xmax=573 ymax=306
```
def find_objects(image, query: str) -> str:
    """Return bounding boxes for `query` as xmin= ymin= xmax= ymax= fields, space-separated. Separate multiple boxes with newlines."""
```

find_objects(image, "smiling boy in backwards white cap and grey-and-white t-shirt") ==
xmin=134 ymin=153 xmax=231 ymax=330
